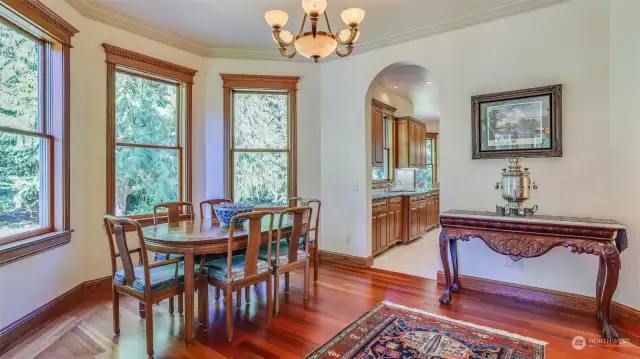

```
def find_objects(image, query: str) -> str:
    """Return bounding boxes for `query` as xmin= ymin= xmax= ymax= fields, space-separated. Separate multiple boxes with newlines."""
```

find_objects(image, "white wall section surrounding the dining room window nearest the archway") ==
xmin=202 ymin=59 xmax=320 ymax=207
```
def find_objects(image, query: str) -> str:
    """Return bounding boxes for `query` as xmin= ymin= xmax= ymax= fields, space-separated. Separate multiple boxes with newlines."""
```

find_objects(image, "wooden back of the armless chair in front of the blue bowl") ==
xmin=227 ymin=211 xmax=273 ymax=281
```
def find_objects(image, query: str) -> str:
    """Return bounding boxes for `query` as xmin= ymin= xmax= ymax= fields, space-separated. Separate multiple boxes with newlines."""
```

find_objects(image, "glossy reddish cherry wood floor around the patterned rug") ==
xmin=2 ymin=265 xmax=640 ymax=359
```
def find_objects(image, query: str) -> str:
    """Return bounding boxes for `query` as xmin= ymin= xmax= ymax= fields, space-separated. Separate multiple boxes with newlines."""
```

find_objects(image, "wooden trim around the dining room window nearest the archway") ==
xmin=220 ymin=73 xmax=300 ymax=209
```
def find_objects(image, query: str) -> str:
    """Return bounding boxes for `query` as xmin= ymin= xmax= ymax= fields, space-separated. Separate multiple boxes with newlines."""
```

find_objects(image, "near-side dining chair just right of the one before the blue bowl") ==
xmin=258 ymin=206 xmax=313 ymax=315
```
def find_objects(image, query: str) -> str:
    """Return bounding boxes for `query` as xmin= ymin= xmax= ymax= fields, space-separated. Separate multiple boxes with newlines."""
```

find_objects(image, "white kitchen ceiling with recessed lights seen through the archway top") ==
xmin=373 ymin=64 xmax=440 ymax=121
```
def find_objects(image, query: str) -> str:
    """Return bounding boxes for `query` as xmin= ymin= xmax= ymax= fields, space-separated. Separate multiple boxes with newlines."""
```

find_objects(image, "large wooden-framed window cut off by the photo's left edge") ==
xmin=0 ymin=0 xmax=78 ymax=252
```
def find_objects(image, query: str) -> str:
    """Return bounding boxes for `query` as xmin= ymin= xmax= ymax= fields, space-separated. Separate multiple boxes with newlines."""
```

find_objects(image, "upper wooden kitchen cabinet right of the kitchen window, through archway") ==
xmin=395 ymin=117 xmax=427 ymax=168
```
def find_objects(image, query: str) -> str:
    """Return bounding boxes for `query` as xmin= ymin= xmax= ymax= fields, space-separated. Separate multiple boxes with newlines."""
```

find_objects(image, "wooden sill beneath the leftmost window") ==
xmin=0 ymin=230 xmax=73 ymax=267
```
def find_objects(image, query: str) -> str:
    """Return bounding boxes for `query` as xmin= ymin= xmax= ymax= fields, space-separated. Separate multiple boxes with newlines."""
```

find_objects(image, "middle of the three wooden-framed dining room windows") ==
xmin=103 ymin=44 xmax=195 ymax=219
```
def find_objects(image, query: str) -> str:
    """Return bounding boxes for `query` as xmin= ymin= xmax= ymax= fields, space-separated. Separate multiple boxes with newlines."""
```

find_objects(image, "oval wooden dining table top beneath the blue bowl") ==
xmin=142 ymin=213 xmax=293 ymax=246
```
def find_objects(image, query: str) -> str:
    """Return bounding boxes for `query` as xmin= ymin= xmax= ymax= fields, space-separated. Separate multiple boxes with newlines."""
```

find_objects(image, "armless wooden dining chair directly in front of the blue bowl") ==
xmin=204 ymin=211 xmax=273 ymax=341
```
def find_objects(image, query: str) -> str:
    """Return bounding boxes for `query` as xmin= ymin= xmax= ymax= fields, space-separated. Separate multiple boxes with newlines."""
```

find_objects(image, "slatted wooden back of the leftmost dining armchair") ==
xmin=104 ymin=216 xmax=151 ymax=293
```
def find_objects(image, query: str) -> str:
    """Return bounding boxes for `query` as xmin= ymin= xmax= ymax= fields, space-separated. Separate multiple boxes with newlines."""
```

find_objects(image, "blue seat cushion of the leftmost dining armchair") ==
xmin=113 ymin=262 xmax=200 ymax=294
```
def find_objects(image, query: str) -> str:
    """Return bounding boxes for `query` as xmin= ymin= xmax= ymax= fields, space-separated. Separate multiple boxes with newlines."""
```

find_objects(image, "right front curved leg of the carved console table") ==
xmin=600 ymin=243 xmax=620 ymax=341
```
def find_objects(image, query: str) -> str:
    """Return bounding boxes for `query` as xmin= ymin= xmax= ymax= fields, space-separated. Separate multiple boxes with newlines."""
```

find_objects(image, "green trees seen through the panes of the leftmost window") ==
xmin=0 ymin=20 xmax=53 ymax=242
